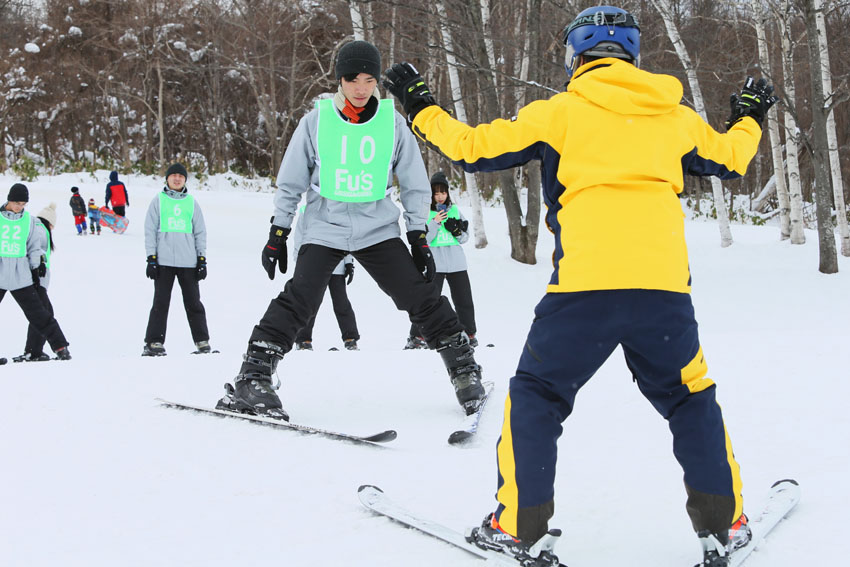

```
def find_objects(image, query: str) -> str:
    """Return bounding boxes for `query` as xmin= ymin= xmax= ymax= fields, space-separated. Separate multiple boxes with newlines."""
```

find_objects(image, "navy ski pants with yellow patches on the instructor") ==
xmin=496 ymin=290 xmax=742 ymax=542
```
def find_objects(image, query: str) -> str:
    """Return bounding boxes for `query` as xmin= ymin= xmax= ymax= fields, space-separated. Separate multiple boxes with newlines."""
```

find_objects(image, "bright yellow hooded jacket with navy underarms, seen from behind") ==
xmin=413 ymin=58 xmax=761 ymax=293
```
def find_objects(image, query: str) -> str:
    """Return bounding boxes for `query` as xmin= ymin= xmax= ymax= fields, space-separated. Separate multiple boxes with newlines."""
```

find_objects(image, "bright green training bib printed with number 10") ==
xmin=316 ymin=99 xmax=395 ymax=203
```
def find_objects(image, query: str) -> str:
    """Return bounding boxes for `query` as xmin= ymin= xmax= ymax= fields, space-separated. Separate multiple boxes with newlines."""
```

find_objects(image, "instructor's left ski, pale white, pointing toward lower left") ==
xmin=357 ymin=484 xmax=536 ymax=567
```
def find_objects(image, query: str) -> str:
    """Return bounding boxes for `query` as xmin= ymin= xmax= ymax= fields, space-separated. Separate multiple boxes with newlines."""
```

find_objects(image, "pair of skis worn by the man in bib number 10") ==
xmin=155 ymin=382 xmax=493 ymax=445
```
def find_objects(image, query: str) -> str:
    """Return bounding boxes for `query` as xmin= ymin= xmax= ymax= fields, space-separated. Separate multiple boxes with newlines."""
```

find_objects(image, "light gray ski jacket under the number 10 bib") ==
xmin=273 ymin=96 xmax=431 ymax=251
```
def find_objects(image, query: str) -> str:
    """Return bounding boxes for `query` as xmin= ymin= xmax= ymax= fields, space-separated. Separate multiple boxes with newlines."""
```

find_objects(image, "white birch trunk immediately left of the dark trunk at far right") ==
xmin=779 ymin=0 xmax=806 ymax=244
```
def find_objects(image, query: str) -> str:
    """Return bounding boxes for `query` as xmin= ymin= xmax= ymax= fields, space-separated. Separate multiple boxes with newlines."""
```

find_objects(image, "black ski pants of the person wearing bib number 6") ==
xmin=145 ymin=266 xmax=210 ymax=343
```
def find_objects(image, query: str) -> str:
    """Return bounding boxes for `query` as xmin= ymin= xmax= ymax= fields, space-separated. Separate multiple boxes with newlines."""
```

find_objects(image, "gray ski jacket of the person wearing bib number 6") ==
xmin=145 ymin=188 xmax=207 ymax=268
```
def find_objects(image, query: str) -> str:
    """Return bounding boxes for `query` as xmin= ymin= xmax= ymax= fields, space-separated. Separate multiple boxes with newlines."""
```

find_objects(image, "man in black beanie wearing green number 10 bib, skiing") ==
xmin=218 ymin=41 xmax=484 ymax=420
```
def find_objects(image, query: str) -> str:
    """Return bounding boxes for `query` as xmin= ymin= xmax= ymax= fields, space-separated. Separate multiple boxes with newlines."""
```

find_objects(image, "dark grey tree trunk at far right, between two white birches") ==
xmin=805 ymin=0 xmax=844 ymax=274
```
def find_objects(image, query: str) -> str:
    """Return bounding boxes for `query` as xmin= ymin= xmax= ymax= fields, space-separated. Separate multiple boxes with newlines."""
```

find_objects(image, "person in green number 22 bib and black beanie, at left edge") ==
xmin=0 ymin=183 xmax=71 ymax=360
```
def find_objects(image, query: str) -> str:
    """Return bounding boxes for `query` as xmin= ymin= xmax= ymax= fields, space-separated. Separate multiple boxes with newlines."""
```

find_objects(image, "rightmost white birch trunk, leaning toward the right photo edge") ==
xmin=811 ymin=0 xmax=850 ymax=256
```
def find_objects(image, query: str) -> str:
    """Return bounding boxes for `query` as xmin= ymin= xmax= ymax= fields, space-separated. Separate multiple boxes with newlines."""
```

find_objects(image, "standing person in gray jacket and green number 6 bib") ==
xmin=142 ymin=163 xmax=212 ymax=356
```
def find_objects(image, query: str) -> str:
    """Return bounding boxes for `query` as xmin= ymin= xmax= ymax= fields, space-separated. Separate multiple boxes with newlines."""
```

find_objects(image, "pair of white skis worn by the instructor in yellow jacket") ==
xmin=357 ymin=479 xmax=800 ymax=567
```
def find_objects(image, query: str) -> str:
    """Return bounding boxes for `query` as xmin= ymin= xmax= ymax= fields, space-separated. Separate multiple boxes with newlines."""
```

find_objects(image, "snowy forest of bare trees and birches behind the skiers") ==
xmin=0 ymin=0 xmax=850 ymax=273
